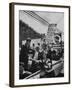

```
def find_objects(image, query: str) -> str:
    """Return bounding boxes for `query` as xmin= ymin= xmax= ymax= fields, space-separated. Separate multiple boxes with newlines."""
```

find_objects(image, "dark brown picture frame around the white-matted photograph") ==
xmin=9 ymin=2 xmax=70 ymax=87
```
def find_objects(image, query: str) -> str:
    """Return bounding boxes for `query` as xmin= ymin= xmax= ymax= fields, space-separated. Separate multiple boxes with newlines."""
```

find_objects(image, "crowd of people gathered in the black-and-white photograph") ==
xmin=19 ymin=38 xmax=64 ymax=79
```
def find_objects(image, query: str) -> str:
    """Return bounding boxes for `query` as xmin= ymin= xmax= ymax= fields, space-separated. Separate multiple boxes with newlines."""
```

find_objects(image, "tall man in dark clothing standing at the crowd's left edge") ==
xmin=20 ymin=38 xmax=31 ymax=70
